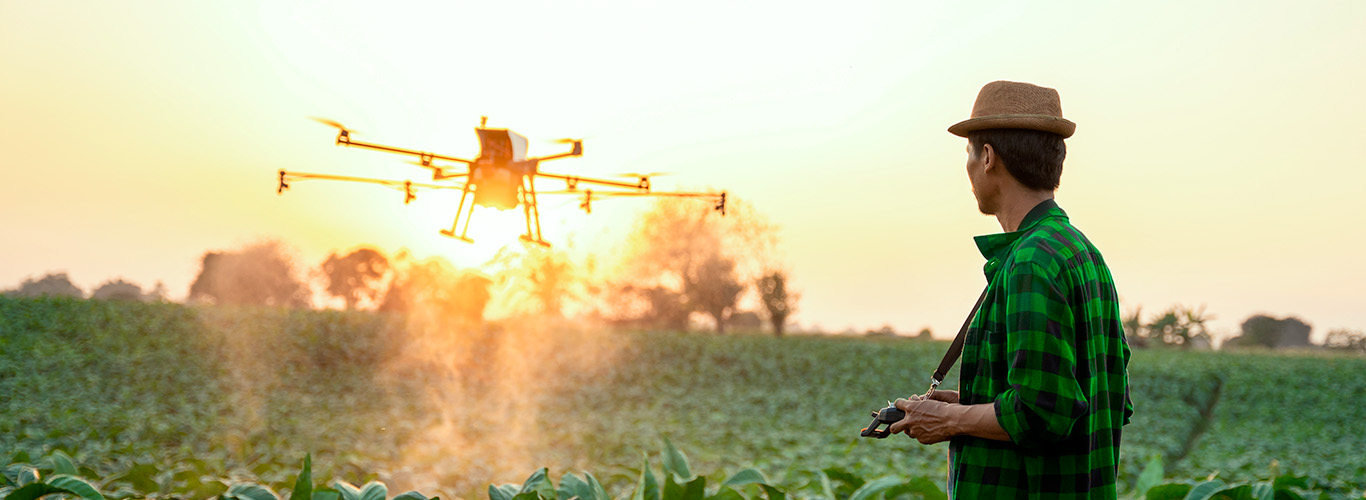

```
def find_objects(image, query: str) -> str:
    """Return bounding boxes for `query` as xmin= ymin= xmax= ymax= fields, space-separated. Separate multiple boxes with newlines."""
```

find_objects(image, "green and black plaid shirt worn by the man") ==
xmin=949 ymin=199 xmax=1134 ymax=499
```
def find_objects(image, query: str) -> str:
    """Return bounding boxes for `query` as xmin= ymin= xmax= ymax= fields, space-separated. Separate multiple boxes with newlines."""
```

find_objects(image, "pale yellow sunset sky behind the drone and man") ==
xmin=0 ymin=1 xmax=1366 ymax=337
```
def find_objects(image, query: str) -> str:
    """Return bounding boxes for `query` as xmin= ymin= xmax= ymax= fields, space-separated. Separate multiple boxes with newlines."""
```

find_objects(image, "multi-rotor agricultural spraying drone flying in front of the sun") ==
xmin=276 ymin=116 xmax=725 ymax=247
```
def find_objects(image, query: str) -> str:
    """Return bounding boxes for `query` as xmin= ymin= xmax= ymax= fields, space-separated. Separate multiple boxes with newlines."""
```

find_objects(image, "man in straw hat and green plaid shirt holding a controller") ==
xmin=891 ymin=82 xmax=1134 ymax=499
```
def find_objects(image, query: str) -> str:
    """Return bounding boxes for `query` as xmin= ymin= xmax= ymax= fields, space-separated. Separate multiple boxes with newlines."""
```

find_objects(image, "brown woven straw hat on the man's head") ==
xmin=948 ymin=81 xmax=1076 ymax=139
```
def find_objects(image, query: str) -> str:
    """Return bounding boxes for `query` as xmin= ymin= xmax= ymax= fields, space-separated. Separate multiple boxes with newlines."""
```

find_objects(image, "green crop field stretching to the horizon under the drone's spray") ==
xmin=0 ymin=296 xmax=1366 ymax=500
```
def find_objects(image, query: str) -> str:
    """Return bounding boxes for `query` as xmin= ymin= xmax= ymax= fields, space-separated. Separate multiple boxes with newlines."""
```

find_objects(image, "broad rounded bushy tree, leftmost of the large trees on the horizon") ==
xmin=190 ymin=242 xmax=309 ymax=307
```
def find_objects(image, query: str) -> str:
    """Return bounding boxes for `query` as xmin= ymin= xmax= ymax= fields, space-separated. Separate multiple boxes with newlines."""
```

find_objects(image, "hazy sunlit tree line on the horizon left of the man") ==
xmin=7 ymin=199 xmax=800 ymax=335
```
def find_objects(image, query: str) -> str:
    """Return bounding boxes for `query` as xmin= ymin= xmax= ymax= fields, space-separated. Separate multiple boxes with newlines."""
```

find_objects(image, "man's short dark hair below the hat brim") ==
xmin=967 ymin=128 xmax=1067 ymax=191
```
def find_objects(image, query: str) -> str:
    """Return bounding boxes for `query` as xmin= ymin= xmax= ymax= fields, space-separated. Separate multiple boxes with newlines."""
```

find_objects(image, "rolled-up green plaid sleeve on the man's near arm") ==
xmin=994 ymin=262 xmax=1087 ymax=447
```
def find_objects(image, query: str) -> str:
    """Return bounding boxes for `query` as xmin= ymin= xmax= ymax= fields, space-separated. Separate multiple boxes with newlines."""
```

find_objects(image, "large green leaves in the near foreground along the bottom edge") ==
xmin=0 ymin=441 xmax=1346 ymax=500
